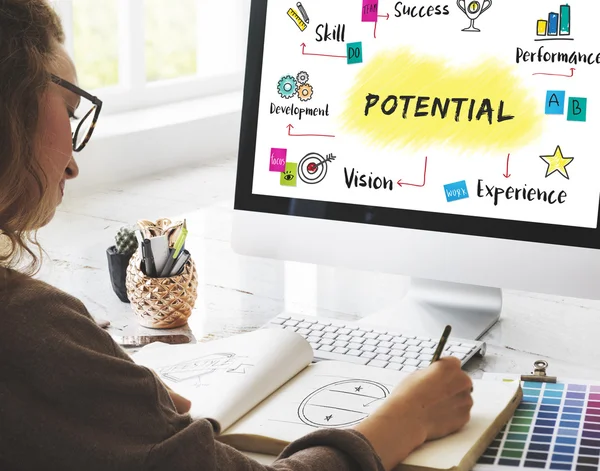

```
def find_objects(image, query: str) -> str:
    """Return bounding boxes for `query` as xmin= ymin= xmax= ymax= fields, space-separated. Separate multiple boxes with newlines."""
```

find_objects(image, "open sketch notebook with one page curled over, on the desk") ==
xmin=133 ymin=329 xmax=522 ymax=471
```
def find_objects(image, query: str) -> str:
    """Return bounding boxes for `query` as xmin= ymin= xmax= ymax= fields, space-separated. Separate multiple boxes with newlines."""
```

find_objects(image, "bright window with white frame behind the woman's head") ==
xmin=51 ymin=0 xmax=250 ymax=114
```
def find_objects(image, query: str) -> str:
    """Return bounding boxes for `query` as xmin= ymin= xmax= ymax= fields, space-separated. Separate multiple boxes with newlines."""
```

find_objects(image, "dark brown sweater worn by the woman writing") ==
xmin=0 ymin=268 xmax=383 ymax=471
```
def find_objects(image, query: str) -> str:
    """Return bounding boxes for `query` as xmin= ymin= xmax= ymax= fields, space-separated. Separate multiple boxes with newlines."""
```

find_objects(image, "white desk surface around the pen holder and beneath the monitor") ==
xmin=40 ymin=160 xmax=600 ymax=432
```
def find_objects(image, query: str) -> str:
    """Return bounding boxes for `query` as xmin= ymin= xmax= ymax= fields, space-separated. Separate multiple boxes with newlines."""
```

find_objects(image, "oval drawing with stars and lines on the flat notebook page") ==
xmin=298 ymin=379 xmax=390 ymax=428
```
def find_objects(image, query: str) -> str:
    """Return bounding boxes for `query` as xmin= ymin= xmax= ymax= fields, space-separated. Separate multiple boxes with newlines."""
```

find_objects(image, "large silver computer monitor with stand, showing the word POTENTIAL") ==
xmin=233 ymin=0 xmax=600 ymax=339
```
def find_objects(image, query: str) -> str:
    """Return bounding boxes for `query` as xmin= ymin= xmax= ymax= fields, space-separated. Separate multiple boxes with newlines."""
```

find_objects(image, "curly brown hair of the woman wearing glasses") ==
xmin=0 ymin=0 xmax=64 ymax=274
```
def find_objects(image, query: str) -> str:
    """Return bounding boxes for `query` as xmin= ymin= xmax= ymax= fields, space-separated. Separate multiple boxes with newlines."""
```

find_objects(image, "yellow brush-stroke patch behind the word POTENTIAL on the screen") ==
xmin=342 ymin=49 xmax=544 ymax=151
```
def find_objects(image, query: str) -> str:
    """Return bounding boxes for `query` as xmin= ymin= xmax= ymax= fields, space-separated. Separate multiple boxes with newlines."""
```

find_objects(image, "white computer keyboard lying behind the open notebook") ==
xmin=264 ymin=314 xmax=486 ymax=372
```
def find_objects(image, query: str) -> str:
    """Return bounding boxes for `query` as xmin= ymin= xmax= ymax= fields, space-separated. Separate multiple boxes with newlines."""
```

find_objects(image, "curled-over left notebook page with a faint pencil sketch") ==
xmin=133 ymin=329 xmax=313 ymax=431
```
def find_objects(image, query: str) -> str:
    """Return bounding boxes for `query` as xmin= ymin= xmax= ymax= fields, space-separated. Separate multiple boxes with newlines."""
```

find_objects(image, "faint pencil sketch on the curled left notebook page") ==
xmin=158 ymin=353 xmax=254 ymax=386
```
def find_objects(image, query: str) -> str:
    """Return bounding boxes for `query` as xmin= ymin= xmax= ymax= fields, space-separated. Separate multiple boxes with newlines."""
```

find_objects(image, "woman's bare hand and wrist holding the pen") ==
xmin=355 ymin=357 xmax=473 ymax=469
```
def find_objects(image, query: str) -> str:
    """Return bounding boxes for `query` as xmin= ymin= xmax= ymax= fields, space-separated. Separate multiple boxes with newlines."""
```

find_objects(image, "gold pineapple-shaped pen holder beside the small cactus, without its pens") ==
xmin=126 ymin=252 xmax=198 ymax=329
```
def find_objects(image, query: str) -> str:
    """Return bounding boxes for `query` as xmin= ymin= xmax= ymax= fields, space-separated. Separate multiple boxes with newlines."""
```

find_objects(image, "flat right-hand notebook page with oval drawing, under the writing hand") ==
xmin=221 ymin=362 xmax=518 ymax=469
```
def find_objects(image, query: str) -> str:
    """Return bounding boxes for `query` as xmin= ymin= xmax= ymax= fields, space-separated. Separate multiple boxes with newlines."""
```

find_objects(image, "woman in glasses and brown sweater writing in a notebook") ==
xmin=0 ymin=0 xmax=472 ymax=471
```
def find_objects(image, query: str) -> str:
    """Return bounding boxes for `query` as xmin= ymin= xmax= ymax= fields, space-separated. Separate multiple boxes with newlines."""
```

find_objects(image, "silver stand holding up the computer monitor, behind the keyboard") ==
xmin=359 ymin=278 xmax=502 ymax=340
